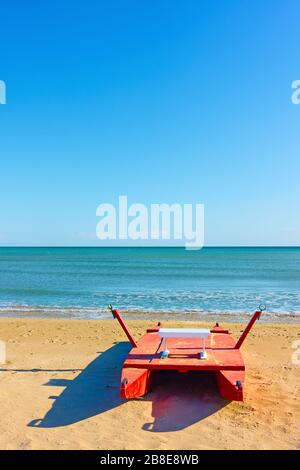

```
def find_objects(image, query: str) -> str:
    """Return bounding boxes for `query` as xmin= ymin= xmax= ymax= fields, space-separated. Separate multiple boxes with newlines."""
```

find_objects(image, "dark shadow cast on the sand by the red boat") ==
xmin=28 ymin=342 xmax=228 ymax=432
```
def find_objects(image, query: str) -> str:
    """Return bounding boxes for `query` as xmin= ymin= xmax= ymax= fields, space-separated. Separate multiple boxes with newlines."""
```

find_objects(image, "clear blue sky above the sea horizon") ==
xmin=0 ymin=0 xmax=300 ymax=245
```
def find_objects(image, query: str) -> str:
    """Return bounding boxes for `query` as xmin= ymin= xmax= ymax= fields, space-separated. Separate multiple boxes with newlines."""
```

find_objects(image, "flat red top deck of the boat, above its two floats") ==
xmin=123 ymin=332 xmax=245 ymax=372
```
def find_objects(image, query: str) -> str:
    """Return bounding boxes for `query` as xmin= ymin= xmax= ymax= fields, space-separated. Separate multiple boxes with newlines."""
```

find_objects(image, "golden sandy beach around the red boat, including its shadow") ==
xmin=0 ymin=318 xmax=300 ymax=450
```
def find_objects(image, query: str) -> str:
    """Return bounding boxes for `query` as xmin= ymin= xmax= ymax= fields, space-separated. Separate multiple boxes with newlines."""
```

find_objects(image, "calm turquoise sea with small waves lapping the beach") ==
xmin=0 ymin=248 xmax=300 ymax=318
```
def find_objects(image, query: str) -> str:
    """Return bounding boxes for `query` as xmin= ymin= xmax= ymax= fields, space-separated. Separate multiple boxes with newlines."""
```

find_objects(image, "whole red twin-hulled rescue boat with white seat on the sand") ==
xmin=110 ymin=306 xmax=264 ymax=401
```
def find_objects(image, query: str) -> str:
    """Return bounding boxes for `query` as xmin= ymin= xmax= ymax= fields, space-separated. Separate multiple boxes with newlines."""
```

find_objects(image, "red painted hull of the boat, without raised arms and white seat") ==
xmin=121 ymin=329 xmax=245 ymax=401
